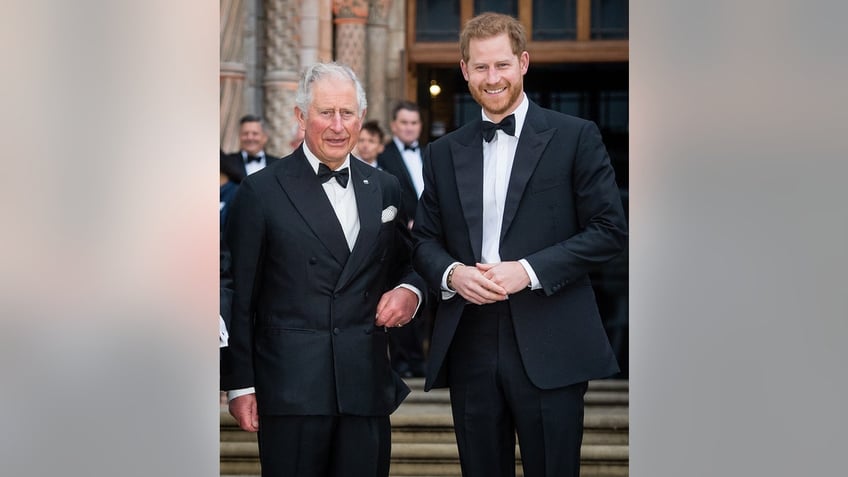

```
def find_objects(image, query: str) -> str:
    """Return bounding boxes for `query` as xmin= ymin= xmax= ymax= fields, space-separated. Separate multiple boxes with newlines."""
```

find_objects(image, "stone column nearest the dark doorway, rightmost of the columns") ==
xmin=365 ymin=0 xmax=392 ymax=124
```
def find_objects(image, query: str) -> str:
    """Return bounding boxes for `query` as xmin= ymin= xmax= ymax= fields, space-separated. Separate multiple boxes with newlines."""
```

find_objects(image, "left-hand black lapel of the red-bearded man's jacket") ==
xmin=450 ymin=136 xmax=483 ymax=261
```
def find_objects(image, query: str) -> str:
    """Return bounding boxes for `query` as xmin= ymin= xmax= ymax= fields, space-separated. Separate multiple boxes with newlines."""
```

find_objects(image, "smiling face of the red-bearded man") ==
xmin=459 ymin=33 xmax=530 ymax=122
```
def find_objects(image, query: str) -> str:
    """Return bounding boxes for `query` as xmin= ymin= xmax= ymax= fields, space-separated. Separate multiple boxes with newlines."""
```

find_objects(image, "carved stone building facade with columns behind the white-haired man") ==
xmin=220 ymin=0 xmax=406 ymax=156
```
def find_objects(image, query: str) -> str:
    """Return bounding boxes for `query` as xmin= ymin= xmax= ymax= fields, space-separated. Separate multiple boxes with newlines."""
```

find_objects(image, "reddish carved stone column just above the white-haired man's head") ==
xmin=333 ymin=0 xmax=368 ymax=80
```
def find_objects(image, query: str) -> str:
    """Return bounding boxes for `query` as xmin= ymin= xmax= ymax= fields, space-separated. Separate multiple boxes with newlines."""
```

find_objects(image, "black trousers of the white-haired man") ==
xmin=259 ymin=416 xmax=392 ymax=477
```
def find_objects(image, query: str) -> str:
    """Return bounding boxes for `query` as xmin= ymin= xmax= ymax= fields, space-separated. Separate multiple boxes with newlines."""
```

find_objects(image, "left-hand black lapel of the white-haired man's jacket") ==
xmin=277 ymin=155 xmax=350 ymax=265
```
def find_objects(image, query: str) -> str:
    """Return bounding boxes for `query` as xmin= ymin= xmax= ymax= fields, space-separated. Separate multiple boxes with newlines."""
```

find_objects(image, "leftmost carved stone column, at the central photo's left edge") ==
xmin=220 ymin=0 xmax=247 ymax=152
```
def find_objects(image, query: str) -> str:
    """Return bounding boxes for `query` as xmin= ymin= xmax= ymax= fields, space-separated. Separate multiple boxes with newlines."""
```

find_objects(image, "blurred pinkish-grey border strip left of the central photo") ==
xmin=0 ymin=0 xmax=219 ymax=477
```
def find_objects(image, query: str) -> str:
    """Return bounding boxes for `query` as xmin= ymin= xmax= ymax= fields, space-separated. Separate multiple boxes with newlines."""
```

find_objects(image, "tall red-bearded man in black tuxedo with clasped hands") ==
xmin=413 ymin=13 xmax=627 ymax=477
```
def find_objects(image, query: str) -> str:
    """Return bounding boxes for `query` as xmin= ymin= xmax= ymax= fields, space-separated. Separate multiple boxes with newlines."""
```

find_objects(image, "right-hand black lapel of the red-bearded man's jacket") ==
xmin=501 ymin=122 xmax=554 ymax=241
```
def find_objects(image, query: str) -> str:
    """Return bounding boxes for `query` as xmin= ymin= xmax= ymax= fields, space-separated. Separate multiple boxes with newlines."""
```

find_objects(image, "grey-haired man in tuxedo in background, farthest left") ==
xmin=221 ymin=114 xmax=279 ymax=184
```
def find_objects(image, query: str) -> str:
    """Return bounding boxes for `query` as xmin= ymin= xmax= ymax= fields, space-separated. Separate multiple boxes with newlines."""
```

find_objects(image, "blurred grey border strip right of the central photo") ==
xmin=630 ymin=1 xmax=848 ymax=477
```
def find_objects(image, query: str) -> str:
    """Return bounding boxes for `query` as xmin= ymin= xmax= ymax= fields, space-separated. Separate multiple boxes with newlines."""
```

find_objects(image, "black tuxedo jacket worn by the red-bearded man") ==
xmin=413 ymin=102 xmax=627 ymax=389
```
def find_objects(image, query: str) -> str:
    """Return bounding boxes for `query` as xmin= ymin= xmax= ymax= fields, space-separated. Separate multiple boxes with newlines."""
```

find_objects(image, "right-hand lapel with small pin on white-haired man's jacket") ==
xmin=336 ymin=162 xmax=383 ymax=289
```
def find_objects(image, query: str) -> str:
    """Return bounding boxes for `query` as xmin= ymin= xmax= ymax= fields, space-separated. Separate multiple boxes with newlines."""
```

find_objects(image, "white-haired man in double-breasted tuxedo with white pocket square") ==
xmin=225 ymin=63 xmax=424 ymax=477
